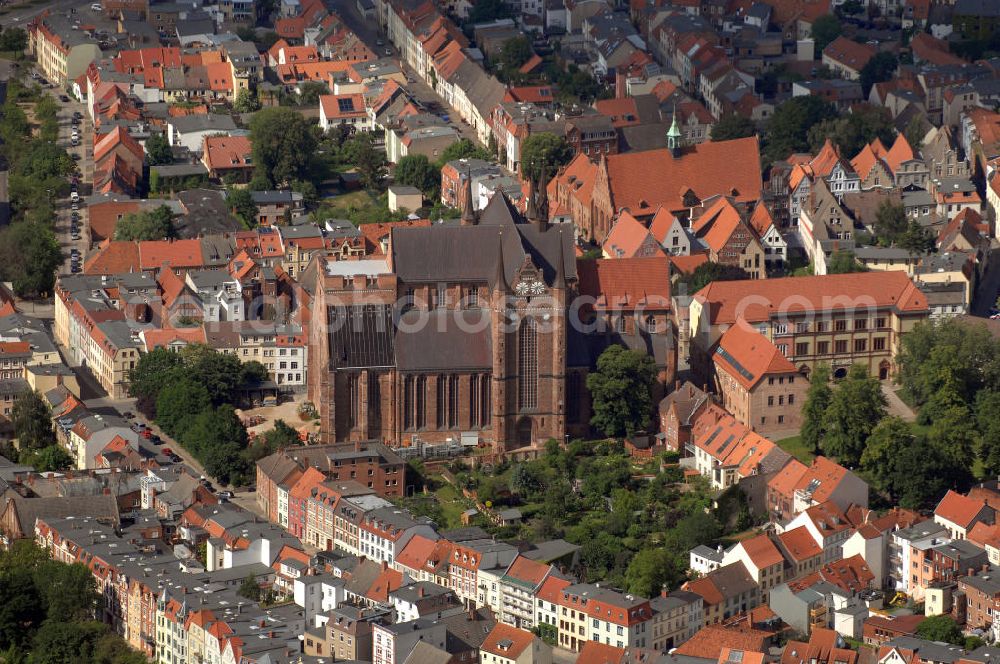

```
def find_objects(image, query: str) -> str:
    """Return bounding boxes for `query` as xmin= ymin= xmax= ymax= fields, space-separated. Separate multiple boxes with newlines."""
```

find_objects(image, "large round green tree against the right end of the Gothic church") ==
xmin=587 ymin=344 xmax=656 ymax=436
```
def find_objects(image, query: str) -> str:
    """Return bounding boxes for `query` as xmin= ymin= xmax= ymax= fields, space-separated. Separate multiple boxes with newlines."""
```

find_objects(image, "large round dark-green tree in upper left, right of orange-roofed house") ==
xmin=250 ymin=107 xmax=316 ymax=185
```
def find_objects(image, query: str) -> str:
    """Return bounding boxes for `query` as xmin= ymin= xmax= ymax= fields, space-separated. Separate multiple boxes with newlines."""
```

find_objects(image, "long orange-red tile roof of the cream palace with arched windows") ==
xmin=695 ymin=272 xmax=927 ymax=325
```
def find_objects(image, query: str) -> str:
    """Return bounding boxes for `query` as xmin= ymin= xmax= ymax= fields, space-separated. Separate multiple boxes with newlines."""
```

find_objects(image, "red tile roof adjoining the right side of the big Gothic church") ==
xmin=576 ymin=256 xmax=670 ymax=310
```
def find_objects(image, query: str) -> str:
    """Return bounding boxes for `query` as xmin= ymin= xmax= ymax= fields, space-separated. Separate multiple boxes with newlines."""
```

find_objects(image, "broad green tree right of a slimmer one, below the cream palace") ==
xmin=823 ymin=364 xmax=886 ymax=467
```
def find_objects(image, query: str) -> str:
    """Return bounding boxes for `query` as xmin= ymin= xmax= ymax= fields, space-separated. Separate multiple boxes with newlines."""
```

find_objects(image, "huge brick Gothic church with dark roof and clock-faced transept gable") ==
xmin=309 ymin=179 xmax=672 ymax=454
